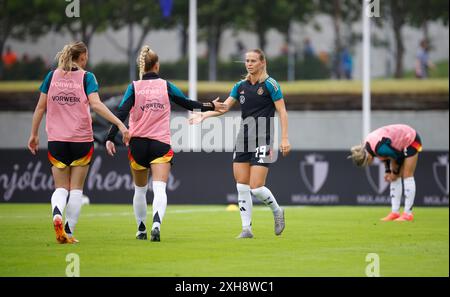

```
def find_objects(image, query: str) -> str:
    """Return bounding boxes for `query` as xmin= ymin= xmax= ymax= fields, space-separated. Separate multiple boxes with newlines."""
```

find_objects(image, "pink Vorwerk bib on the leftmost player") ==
xmin=46 ymin=69 xmax=94 ymax=142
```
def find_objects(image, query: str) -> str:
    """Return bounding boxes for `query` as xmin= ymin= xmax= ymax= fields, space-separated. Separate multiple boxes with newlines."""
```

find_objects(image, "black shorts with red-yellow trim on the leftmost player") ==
xmin=48 ymin=141 xmax=94 ymax=169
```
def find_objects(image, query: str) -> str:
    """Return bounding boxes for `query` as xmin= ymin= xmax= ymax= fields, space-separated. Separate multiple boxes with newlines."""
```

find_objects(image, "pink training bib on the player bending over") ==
xmin=365 ymin=124 xmax=416 ymax=152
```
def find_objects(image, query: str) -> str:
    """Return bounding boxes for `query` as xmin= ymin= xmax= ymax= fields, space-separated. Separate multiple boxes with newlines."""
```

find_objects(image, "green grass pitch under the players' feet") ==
xmin=0 ymin=204 xmax=449 ymax=277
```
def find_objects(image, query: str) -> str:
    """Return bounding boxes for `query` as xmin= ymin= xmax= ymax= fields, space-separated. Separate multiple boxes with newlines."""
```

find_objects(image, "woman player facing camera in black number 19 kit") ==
xmin=190 ymin=49 xmax=291 ymax=238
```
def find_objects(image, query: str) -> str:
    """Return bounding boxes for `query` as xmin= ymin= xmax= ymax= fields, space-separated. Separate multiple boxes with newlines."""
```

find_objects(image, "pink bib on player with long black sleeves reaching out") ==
xmin=129 ymin=78 xmax=170 ymax=145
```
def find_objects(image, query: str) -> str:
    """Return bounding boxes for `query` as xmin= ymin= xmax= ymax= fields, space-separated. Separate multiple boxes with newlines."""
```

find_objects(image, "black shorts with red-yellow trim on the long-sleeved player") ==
xmin=128 ymin=137 xmax=174 ymax=170
